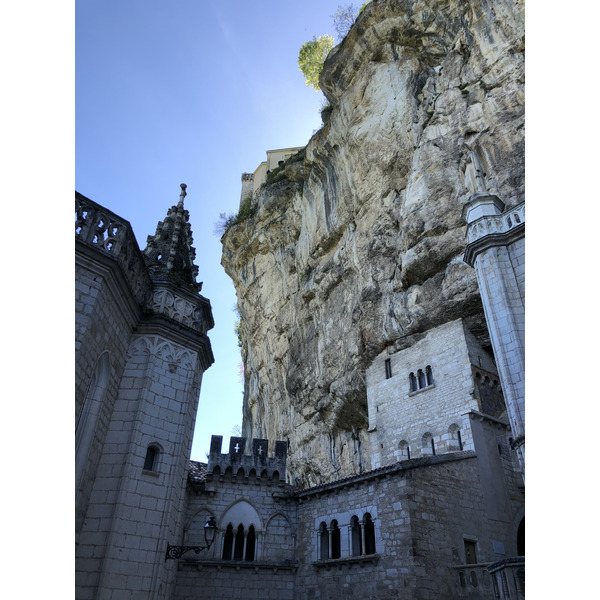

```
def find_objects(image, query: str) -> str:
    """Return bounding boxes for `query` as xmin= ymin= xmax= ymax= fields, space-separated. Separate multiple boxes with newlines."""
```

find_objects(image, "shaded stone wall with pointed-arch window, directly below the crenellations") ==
xmin=174 ymin=470 xmax=298 ymax=600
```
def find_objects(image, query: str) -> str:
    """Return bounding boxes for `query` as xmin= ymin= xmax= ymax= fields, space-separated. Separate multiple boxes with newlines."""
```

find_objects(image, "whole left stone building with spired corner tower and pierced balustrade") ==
xmin=76 ymin=184 xmax=214 ymax=600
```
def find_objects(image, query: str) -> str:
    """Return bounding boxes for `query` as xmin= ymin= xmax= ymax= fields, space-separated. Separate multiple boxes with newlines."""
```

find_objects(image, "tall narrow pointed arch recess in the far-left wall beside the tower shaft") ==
xmin=75 ymin=351 xmax=112 ymax=494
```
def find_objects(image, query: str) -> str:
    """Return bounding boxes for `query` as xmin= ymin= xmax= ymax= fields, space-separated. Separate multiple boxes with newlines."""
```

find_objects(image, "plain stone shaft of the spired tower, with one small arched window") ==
xmin=76 ymin=335 xmax=201 ymax=600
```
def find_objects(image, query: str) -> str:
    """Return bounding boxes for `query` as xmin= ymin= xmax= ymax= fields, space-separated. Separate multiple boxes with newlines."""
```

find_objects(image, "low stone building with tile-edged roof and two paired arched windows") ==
xmin=296 ymin=453 xmax=520 ymax=600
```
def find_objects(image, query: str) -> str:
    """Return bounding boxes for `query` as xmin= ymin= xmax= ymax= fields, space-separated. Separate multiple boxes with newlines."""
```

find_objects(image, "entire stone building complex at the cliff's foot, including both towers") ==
xmin=75 ymin=179 xmax=525 ymax=600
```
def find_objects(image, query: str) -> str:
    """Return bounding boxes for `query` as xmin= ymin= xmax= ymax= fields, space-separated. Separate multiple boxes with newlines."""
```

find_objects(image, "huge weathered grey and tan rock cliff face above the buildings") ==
xmin=222 ymin=0 xmax=524 ymax=485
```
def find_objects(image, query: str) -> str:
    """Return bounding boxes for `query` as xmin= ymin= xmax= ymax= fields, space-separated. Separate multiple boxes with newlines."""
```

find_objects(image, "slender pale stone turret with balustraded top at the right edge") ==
xmin=463 ymin=193 xmax=525 ymax=477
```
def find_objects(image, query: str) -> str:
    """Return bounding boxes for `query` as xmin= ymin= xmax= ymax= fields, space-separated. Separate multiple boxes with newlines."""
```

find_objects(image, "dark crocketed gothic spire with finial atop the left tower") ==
xmin=143 ymin=183 xmax=202 ymax=292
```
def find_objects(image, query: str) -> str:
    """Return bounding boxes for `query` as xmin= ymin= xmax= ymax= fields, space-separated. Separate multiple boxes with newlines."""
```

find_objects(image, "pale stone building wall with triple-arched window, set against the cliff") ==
xmin=366 ymin=319 xmax=502 ymax=468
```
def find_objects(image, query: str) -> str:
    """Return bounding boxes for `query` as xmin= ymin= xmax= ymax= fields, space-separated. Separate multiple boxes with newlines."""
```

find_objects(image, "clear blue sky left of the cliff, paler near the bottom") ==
xmin=75 ymin=0 xmax=350 ymax=461
